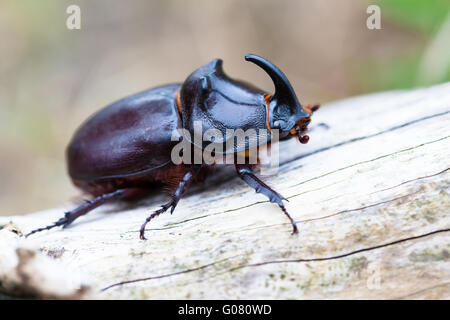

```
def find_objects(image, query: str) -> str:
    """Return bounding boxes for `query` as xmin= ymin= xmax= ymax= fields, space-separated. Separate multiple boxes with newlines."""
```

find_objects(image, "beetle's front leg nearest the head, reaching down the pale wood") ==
xmin=235 ymin=164 xmax=298 ymax=234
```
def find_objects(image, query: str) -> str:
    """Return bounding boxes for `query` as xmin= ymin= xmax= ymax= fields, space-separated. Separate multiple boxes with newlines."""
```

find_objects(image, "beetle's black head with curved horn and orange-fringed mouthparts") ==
xmin=245 ymin=54 xmax=318 ymax=143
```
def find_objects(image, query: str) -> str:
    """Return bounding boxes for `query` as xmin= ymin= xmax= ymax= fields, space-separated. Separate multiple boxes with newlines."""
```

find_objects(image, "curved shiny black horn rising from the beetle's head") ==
xmin=245 ymin=54 xmax=301 ymax=112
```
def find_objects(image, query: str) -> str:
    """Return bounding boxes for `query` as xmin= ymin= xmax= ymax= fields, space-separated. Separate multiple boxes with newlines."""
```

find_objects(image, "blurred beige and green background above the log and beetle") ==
xmin=0 ymin=0 xmax=450 ymax=215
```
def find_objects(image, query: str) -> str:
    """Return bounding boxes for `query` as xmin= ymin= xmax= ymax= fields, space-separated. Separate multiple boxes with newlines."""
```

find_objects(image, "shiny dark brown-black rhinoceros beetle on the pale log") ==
xmin=27 ymin=54 xmax=319 ymax=240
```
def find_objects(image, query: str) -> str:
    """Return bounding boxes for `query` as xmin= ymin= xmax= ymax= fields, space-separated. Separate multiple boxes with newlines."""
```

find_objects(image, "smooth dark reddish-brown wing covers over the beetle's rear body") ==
xmin=67 ymin=84 xmax=181 ymax=181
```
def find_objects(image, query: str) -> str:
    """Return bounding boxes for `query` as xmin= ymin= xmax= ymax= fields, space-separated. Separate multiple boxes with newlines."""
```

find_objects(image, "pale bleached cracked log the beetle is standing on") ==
xmin=0 ymin=83 xmax=450 ymax=299
